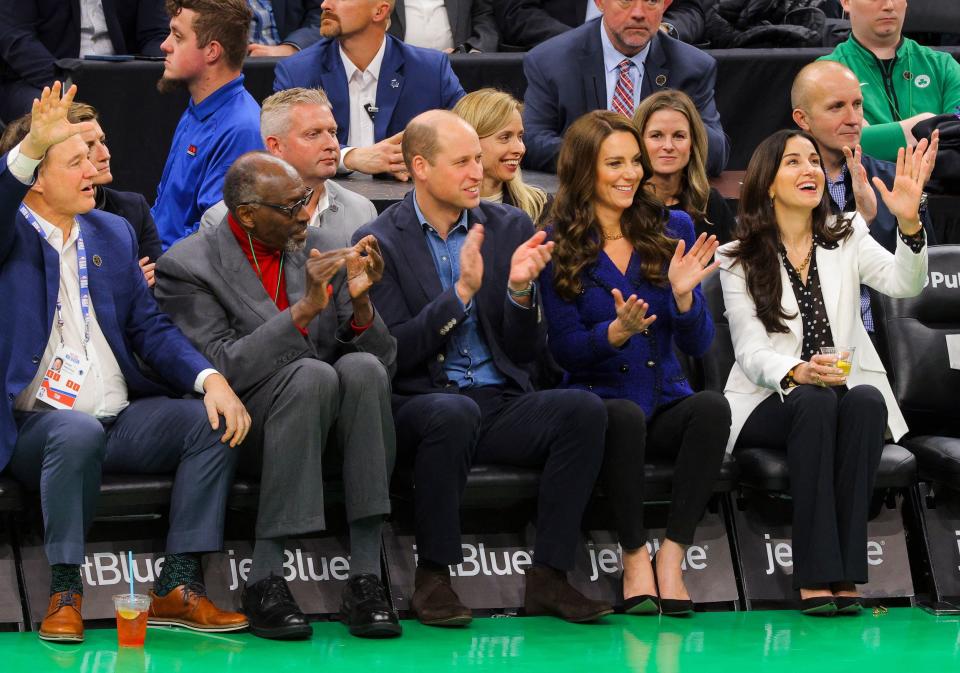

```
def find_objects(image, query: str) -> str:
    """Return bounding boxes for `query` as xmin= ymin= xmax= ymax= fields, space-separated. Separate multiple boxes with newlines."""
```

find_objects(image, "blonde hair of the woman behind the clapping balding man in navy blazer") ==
xmin=453 ymin=88 xmax=547 ymax=222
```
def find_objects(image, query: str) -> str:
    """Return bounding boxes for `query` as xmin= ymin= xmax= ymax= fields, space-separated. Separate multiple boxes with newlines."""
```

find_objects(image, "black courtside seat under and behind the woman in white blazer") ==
xmin=702 ymin=274 xmax=920 ymax=491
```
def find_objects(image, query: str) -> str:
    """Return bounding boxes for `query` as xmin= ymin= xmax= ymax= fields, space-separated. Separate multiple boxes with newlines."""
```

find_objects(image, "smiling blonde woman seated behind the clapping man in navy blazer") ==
xmin=453 ymin=89 xmax=549 ymax=223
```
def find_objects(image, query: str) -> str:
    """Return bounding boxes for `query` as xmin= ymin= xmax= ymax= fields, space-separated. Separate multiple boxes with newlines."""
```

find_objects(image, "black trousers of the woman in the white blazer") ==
xmin=736 ymin=385 xmax=887 ymax=589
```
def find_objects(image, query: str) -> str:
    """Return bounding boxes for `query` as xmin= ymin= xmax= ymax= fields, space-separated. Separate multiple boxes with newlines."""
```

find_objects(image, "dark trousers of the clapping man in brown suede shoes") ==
xmin=394 ymin=387 xmax=607 ymax=570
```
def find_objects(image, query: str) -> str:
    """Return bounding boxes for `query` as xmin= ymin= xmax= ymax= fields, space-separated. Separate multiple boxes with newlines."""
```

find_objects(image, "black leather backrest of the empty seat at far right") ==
xmin=874 ymin=245 xmax=960 ymax=432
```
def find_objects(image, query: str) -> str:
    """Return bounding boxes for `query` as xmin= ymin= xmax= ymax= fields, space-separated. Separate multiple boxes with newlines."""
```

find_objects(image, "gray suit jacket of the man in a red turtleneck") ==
xmin=154 ymin=217 xmax=397 ymax=397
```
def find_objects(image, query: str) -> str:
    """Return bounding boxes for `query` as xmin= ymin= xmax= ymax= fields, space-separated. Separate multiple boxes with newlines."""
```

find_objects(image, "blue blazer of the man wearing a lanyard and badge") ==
xmin=0 ymin=155 xmax=210 ymax=470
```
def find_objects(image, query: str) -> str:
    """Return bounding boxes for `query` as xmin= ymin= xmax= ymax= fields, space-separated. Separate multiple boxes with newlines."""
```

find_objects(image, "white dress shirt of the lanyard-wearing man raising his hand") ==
xmin=7 ymin=145 xmax=217 ymax=418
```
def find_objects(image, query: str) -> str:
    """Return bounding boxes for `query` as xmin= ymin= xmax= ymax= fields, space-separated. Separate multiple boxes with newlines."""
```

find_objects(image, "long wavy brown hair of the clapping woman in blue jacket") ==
xmin=550 ymin=110 xmax=677 ymax=300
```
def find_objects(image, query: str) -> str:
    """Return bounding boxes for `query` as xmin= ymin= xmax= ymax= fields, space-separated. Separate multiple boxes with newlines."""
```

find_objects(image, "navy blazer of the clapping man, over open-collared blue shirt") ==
xmin=353 ymin=191 xmax=545 ymax=395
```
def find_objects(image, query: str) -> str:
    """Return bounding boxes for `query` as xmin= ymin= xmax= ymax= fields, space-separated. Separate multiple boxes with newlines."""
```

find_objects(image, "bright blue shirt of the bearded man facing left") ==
xmin=150 ymin=75 xmax=263 ymax=250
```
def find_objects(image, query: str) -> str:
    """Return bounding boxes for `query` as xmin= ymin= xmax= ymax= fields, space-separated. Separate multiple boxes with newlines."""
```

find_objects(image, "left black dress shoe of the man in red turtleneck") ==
xmin=240 ymin=573 xmax=313 ymax=640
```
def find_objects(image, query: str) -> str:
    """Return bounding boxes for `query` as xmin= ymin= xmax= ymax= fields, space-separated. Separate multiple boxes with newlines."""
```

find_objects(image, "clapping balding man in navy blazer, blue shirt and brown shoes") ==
xmin=354 ymin=110 xmax=612 ymax=626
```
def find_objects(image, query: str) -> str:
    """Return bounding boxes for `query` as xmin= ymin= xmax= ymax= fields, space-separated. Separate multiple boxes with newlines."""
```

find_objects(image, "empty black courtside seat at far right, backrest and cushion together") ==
xmin=873 ymin=245 xmax=960 ymax=489
